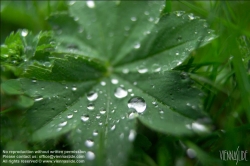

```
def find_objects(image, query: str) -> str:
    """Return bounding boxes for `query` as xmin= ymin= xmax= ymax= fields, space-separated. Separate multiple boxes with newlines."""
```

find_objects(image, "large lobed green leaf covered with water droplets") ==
xmin=0 ymin=1 xmax=214 ymax=165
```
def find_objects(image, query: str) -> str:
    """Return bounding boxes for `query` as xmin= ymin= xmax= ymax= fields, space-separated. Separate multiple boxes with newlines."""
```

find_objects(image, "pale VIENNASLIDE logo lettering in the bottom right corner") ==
xmin=220 ymin=146 xmax=248 ymax=165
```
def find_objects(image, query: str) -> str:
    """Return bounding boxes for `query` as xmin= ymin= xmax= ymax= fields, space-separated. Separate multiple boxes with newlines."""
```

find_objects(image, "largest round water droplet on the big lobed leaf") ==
xmin=128 ymin=96 xmax=146 ymax=113
